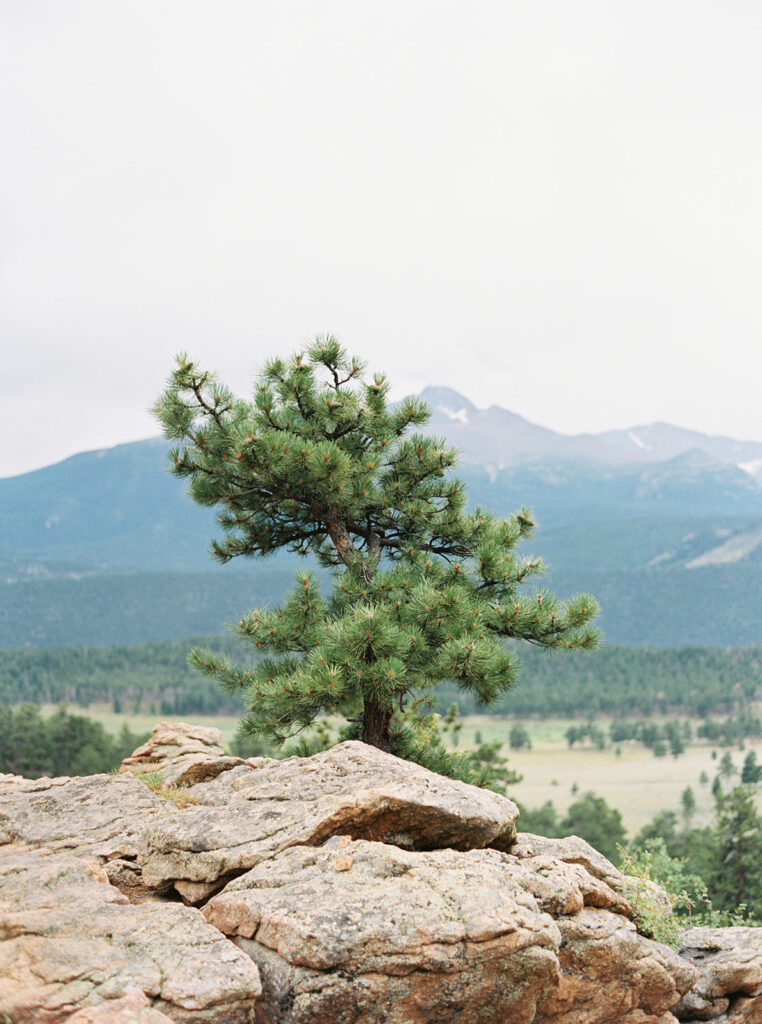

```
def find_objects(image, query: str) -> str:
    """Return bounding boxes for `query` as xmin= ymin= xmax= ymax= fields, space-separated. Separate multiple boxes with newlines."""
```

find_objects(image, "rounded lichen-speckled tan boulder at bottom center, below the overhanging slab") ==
xmin=204 ymin=838 xmax=559 ymax=1024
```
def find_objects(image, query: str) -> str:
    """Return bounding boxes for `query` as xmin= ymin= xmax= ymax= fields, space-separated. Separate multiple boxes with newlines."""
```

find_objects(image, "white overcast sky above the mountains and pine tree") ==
xmin=0 ymin=0 xmax=762 ymax=475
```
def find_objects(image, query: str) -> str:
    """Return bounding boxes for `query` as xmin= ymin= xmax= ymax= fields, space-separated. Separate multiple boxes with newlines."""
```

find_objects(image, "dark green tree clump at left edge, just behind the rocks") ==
xmin=0 ymin=705 xmax=149 ymax=778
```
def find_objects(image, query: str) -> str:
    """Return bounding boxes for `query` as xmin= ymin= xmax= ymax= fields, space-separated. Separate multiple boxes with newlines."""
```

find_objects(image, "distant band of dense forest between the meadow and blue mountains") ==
xmin=0 ymin=635 xmax=762 ymax=720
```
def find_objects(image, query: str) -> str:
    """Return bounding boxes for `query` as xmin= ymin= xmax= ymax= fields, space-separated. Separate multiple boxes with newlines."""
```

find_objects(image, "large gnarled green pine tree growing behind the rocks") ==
xmin=155 ymin=337 xmax=598 ymax=751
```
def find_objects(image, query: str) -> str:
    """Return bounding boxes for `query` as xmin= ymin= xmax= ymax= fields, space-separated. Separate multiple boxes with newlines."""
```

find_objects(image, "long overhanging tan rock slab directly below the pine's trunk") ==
xmin=139 ymin=741 xmax=518 ymax=891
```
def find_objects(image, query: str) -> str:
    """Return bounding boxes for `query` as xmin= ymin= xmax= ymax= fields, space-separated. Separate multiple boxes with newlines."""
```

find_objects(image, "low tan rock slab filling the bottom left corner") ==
xmin=0 ymin=845 xmax=261 ymax=1024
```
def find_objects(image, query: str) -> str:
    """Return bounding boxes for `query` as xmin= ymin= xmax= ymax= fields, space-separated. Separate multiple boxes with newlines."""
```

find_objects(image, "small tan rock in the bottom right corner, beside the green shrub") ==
xmin=675 ymin=928 xmax=762 ymax=1024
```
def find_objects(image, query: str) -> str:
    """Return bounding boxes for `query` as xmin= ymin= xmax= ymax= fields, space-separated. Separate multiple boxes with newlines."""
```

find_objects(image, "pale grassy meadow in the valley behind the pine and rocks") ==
xmin=68 ymin=705 xmax=762 ymax=836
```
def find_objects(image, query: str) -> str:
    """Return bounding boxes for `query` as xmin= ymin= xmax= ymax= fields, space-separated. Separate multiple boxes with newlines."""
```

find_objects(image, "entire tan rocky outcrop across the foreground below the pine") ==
xmin=0 ymin=724 xmax=760 ymax=1024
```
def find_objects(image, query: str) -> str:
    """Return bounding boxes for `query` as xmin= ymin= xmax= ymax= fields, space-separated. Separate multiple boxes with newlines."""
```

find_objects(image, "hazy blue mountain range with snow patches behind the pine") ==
xmin=0 ymin=387 xmax=762 ymax=647
